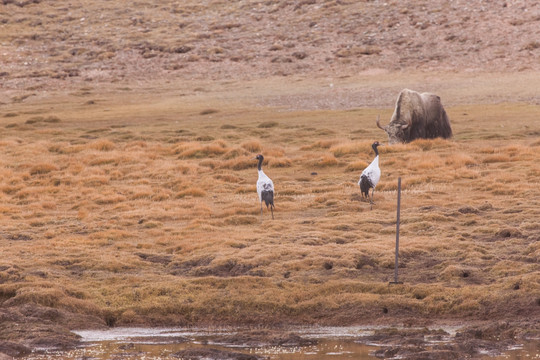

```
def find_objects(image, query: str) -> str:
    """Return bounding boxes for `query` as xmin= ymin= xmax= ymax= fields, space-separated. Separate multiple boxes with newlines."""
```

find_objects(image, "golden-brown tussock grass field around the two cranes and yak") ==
xmin=0 ymin=74 xmax=540 ymax=332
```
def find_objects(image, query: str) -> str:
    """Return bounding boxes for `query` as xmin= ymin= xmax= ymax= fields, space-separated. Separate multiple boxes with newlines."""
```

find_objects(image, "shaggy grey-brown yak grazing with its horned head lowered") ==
xmin=377 ymin=89 xmax=452 ymax=144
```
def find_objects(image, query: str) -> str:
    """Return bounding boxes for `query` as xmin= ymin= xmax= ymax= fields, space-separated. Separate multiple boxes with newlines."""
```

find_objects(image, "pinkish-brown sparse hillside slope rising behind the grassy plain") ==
xmin=0 ymin=0 xmax=540 ymax=93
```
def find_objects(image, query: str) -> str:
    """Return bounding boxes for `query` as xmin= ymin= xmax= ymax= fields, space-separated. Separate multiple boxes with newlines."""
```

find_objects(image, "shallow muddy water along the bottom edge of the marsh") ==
xmin=26 ymin=327 xmax=540 ymax=360
